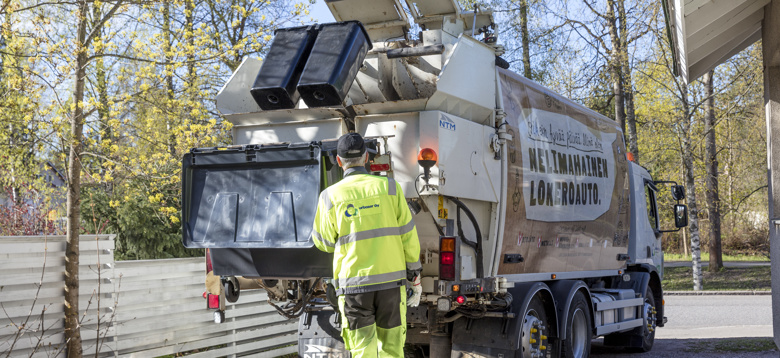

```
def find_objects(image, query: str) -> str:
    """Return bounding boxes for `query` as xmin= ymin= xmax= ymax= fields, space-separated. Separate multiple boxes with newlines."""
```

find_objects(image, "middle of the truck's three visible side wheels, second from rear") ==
xmin=561 ymin=292 xmax=593 ymax=358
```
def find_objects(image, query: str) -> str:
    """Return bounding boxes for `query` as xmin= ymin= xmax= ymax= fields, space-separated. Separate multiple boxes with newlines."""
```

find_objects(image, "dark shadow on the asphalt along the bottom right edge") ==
xmin=591 ymin=337 xmax=780 ymax=358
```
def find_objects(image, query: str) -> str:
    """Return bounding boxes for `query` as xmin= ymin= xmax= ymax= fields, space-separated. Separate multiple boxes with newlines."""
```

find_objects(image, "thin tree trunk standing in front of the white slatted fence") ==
xmin=65 ymin=0 xmax=88 ymax=358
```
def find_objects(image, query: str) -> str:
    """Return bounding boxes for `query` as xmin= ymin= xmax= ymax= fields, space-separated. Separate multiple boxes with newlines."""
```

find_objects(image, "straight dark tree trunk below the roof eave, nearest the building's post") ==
xmin=704 ymin=71 xmax=723 ymax=272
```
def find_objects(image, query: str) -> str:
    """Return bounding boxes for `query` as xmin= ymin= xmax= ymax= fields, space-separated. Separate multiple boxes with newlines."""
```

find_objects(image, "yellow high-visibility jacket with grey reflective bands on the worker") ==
xmin=312 ymin=167 xmax=421 ymax=294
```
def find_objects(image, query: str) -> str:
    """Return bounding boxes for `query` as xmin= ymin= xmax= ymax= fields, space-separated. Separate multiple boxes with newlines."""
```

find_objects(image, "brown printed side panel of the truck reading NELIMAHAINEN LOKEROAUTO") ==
xmin=499 ymin=71 xmax=629 ymax=275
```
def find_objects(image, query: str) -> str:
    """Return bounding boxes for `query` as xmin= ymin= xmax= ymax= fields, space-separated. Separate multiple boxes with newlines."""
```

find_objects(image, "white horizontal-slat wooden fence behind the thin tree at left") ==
xmin=0 ymin=235 xmax=298 ymax=357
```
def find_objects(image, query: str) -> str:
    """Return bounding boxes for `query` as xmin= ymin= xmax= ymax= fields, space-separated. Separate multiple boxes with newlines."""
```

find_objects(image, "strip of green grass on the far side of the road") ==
xmin=661 ymin=266 xmax=772 ymax=291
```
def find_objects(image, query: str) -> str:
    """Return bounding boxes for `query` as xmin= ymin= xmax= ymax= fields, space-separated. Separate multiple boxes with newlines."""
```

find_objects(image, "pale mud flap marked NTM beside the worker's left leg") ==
xmin=298 ymin=310 xmax=351 ymax=358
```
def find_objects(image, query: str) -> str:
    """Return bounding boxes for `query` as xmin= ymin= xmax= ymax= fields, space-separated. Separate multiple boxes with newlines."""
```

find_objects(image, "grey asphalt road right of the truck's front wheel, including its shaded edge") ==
xmin=591 ymin=295 xmax=780 ymax=358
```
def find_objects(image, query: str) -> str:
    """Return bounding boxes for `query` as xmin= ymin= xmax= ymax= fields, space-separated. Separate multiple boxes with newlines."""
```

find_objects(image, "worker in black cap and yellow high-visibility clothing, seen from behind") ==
xmin=312 ymin=133 xmax=422 ymax=358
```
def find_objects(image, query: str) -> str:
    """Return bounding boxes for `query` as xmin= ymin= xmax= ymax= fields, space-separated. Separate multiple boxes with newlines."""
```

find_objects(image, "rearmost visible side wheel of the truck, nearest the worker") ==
xmin=520 ymin=295 xmax=552 ymax=358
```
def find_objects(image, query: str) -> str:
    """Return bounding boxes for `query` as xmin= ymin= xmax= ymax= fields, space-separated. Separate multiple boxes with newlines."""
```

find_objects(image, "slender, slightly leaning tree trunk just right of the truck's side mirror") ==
xmin=681 ymin=84 xmax=703 ymax=291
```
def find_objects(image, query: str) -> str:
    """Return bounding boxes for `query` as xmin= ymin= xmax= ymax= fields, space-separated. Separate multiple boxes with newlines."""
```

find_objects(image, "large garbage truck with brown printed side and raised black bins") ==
xmin=182 ymin=0 xmax=687 ymax=357
